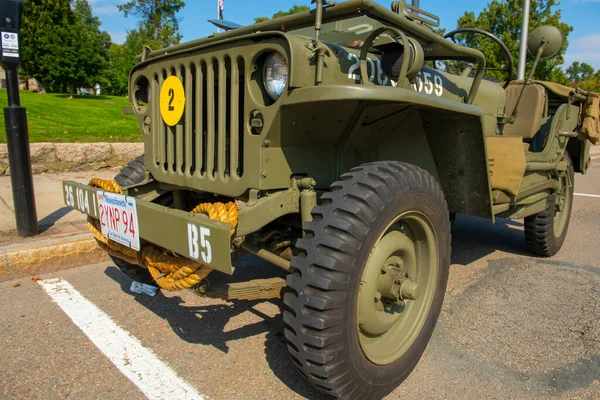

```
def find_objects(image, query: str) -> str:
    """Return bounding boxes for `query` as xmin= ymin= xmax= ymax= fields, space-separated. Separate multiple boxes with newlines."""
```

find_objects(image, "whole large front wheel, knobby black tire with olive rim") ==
xmin=283 ymin=161 xmax=450 ymax=399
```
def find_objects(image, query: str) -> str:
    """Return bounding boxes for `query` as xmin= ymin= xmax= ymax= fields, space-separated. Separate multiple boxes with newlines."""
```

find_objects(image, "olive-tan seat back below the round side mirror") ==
xmin=503 ymin=83 xmax=548 ymax=141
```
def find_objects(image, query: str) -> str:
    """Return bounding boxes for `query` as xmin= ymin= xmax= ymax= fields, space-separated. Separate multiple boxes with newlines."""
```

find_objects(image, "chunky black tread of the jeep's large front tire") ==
xmin=283 ymin=161 xmax=450 ymax=399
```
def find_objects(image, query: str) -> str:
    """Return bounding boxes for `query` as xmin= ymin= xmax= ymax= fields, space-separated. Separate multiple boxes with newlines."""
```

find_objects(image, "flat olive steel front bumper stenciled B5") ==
xmin=63 ymin=181 xmax=233 ymax=274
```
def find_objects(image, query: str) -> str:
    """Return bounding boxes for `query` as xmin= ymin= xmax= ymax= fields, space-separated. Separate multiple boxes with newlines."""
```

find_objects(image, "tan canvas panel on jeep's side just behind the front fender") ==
xmin=486 ymin=136 xmax=526 ymax=196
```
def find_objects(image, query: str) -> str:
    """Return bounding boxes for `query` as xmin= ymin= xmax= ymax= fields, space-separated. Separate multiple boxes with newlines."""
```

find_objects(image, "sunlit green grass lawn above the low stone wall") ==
xmin=0 ymin=90 xmax=142 ymax=143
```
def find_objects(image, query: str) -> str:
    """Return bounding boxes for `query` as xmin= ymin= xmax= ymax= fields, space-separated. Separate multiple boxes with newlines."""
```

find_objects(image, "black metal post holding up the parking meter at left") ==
xmin=4 ymin=69 xmax=39 ymax=237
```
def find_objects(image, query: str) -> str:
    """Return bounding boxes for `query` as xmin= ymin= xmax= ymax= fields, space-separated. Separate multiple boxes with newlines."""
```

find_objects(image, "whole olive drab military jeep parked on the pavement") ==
xmin=64 ymin=0 xmax=598 ymax=399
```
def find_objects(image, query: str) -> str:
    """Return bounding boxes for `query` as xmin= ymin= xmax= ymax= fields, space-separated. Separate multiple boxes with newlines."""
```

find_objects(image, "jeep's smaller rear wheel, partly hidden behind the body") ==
xmin=525 ymin=155 xmax=575 ymax=257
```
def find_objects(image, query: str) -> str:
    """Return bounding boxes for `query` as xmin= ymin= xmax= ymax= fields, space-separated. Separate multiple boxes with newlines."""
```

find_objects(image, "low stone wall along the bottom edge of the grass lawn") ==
xmin=0 ymin=143 xmax=144 ymax=175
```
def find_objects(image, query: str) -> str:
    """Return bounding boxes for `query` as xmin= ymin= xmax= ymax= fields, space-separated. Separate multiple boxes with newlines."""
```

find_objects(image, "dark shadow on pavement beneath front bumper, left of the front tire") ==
xmin=104 ymin=256 xmax=327 ymax=399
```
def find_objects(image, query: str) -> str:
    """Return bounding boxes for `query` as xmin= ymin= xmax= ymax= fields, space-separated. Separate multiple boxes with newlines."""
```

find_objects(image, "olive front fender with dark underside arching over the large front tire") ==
xmin=281 ymin=85 xmax=493 ymax=218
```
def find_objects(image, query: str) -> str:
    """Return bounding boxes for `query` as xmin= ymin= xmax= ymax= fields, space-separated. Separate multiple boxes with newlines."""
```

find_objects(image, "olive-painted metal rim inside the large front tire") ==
xmin=357 ymin=212 xmax=439 ymax=365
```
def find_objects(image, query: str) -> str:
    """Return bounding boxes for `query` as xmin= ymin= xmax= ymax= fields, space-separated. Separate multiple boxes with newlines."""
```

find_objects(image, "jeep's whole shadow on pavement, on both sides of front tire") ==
xmin=105 ymin=215 xmax=540 ymax=399
